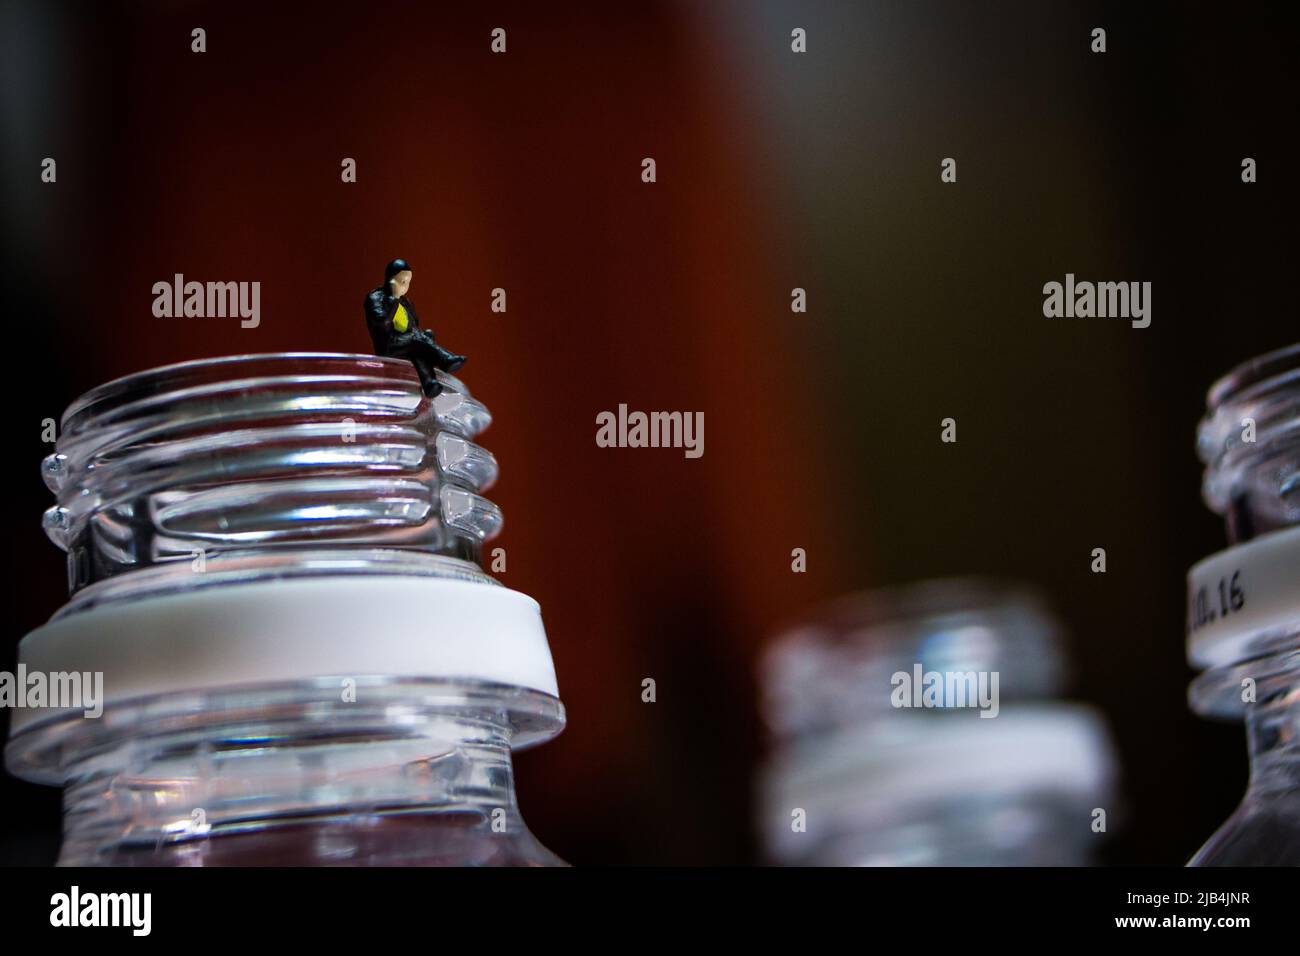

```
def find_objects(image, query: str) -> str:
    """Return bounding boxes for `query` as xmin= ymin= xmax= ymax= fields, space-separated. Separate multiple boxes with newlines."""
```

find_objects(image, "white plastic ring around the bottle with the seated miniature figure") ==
xmin=10 ymin=575 xmax=559 ymax=732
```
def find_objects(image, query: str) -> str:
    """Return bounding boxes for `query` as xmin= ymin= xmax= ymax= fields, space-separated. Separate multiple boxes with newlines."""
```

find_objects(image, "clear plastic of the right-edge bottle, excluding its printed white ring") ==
xmin=1188 ymin=346 xmax=1300 ymax=866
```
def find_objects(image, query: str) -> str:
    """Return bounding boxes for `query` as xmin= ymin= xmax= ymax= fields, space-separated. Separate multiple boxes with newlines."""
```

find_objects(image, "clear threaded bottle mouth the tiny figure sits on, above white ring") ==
xmin=42 ymin=352 xmax=503 ymax=613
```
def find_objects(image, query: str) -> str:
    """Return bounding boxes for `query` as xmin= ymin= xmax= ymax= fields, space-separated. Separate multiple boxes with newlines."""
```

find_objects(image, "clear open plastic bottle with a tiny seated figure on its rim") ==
xmin=5 ymin=354 xmax=564 ymax=866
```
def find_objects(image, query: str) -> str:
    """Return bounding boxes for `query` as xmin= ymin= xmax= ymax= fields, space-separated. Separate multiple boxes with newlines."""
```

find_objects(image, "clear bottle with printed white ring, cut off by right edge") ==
xmin=1187 ymin=346 xmax=1300 ymax=866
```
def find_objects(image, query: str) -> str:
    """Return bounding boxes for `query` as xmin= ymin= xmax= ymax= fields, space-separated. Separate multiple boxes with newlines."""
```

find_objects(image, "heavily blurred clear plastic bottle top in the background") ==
xmin=758 ymin=580 xmax=1117 ymax=866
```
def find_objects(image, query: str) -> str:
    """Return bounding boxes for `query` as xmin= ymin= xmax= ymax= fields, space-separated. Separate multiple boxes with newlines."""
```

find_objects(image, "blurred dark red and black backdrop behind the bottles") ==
xmin=0 ymin=0 xmax=1297 ymax=864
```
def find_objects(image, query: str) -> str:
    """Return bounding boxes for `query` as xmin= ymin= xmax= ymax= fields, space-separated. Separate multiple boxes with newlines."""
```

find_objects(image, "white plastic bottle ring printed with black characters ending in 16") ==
xmin=1187 ymin=525 xmax=1300 ymax=667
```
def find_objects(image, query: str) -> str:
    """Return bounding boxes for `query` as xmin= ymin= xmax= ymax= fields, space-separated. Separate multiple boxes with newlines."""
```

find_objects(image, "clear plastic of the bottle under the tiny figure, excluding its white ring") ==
xmin=5 ymin=352 xmax=564 ymax=866
